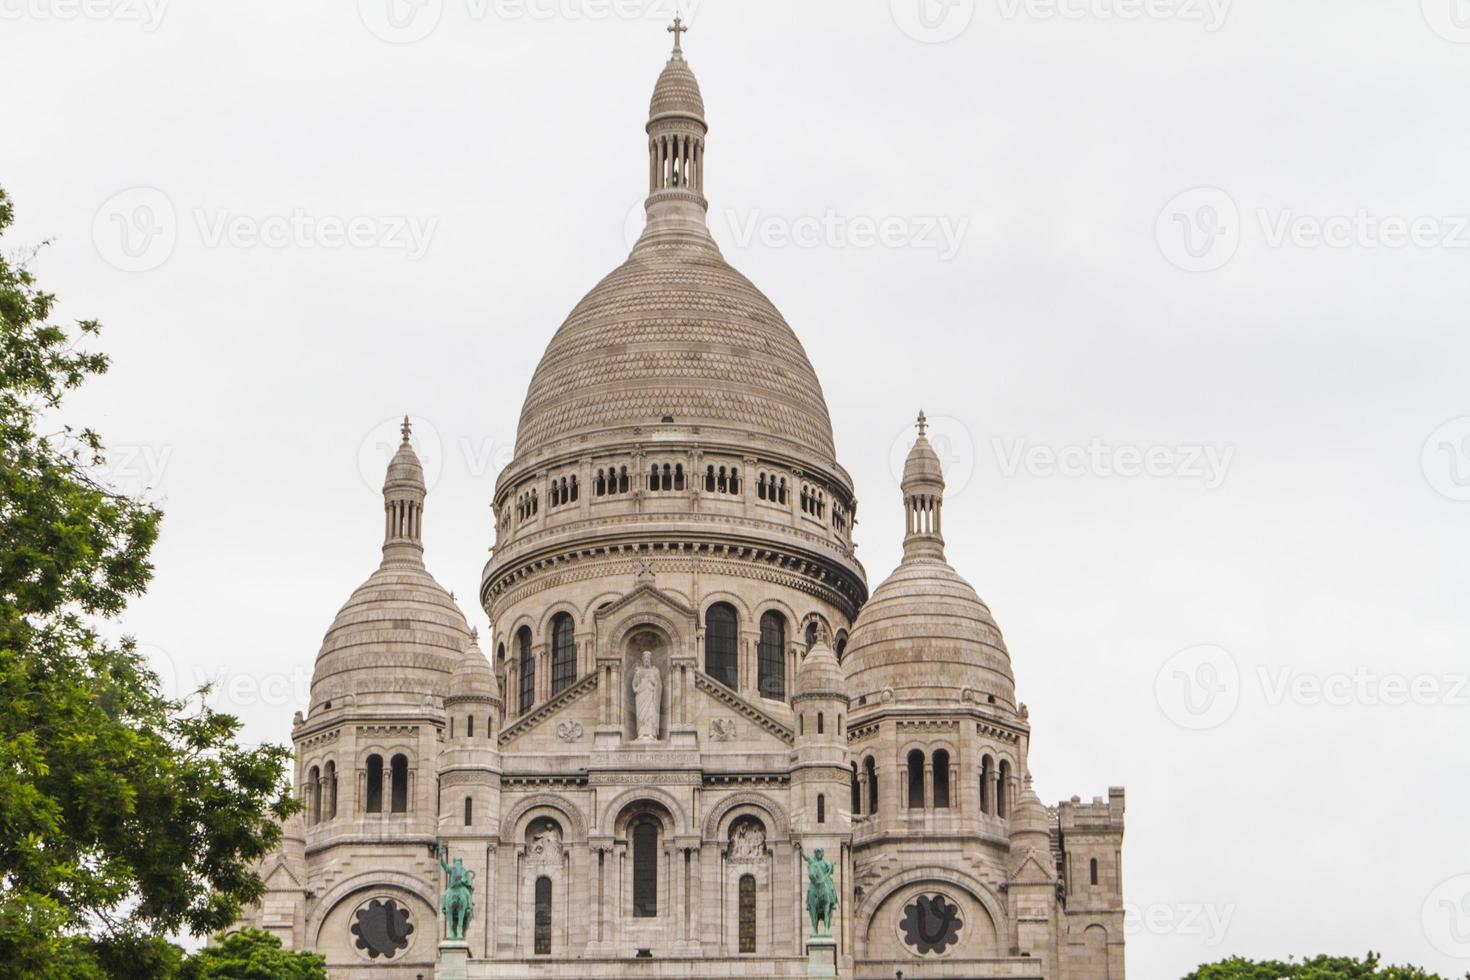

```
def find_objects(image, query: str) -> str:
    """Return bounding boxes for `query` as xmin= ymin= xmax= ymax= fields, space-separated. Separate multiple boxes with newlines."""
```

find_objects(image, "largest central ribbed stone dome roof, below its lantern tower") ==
xmin=516 ymin=233 xmax=835 ymax=464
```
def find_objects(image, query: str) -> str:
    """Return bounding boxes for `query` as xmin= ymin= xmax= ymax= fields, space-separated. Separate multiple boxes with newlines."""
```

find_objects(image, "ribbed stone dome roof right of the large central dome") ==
xmin=842 ymin=554 xmax=1016 ymax=708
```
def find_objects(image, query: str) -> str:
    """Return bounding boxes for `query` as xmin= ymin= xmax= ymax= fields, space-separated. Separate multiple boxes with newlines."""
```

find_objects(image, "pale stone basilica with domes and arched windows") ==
xmin=247 ymin=22 xmax=1125 ymax=980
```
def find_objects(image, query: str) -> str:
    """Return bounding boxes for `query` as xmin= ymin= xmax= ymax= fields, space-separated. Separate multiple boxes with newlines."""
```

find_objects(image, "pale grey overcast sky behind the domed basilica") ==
xmin=0 ymin=0 xmax=1470 ymax=980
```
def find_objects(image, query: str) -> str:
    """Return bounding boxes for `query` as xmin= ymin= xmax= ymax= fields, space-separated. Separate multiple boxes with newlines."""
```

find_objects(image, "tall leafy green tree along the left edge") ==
xmin=0 ymin=190 xmax=297 ymax=979
